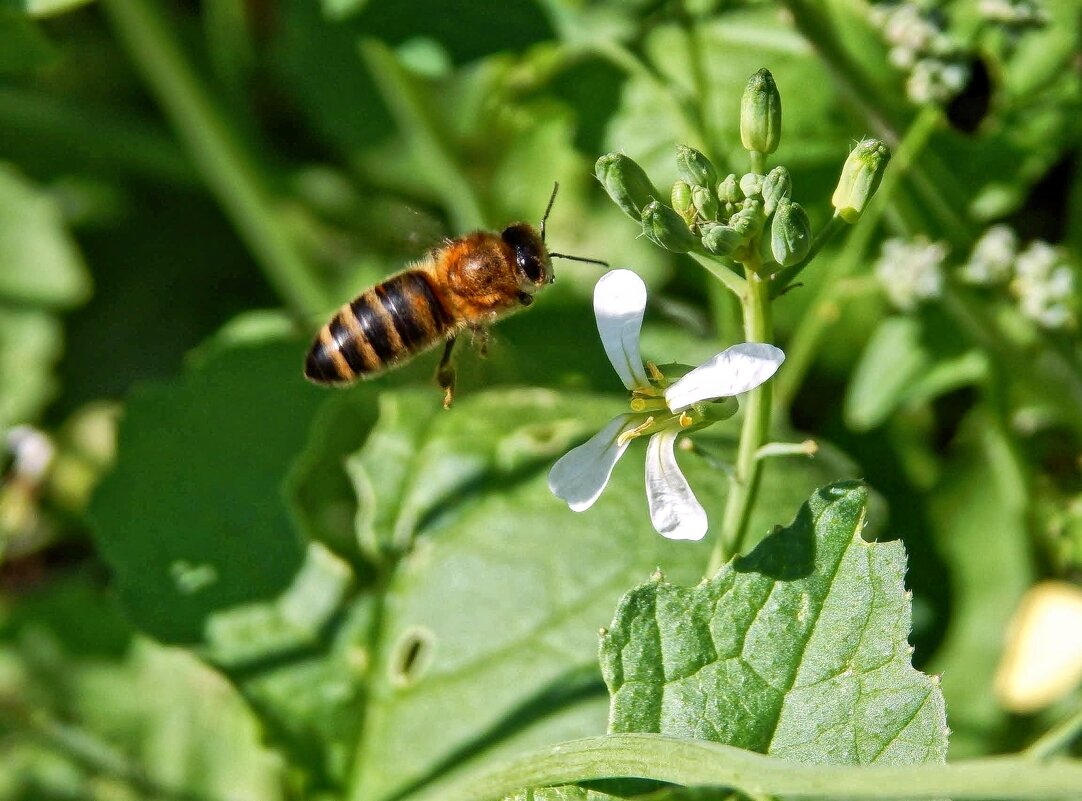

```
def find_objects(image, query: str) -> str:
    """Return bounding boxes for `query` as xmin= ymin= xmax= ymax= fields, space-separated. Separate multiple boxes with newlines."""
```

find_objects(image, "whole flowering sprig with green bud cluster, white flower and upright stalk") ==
xmin=588 ymin=69 xmax=890 ymax=575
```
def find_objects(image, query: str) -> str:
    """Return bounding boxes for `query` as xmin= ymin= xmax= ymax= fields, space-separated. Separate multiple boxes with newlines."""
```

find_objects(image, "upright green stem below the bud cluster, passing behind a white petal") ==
xmin=707 ymin=257 xmax=774 ymax=576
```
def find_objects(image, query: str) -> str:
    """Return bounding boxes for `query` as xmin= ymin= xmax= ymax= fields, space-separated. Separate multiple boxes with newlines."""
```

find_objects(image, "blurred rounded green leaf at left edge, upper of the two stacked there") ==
xmin=0 ymin=163 xmax=90 ymax=306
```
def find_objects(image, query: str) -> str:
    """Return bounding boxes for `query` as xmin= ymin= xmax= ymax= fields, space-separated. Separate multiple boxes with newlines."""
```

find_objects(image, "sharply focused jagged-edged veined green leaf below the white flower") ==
xmin=601 ymin=482 xmax=947 ymax=764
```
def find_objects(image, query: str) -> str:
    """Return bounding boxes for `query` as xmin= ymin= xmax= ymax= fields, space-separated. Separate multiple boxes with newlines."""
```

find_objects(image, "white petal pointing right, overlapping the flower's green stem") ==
xmin=665 ymin=342 xmax=786 ymax=411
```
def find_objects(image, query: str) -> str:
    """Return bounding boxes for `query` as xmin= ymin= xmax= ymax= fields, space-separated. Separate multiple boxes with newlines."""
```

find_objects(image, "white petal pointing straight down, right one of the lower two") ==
xmin=646 ymin=431 xmax=707 ymax=540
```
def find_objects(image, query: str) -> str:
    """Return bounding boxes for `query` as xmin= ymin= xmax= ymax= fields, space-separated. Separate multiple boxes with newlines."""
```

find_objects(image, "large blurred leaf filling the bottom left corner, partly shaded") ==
xmin=0 ymin=570 xmax=283 ymax=801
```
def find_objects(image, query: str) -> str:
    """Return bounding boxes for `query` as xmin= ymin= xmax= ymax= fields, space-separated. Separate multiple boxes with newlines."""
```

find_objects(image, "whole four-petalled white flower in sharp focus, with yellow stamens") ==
xmin=549 ymin=270 xmax=786 ymax=540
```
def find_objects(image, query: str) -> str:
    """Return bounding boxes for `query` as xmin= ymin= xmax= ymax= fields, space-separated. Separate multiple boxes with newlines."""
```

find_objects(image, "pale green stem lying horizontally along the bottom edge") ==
xmin=407 ymin=734 xmax=1082 ymax=801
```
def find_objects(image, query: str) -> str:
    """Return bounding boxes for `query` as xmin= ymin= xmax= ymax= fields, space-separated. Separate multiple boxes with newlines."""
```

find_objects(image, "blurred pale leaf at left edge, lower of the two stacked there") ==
xmin=0 ymin=309 xmax=62 ymax=430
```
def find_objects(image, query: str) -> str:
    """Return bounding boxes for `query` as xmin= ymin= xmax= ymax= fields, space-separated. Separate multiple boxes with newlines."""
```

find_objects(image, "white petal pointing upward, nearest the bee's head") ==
xmin=594 ymin=270 xmax=650 ymax=390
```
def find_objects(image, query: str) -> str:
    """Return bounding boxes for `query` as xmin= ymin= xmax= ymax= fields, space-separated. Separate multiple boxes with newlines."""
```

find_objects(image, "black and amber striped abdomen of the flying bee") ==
xmin=304 ymin=270 xmax=453 ymax=383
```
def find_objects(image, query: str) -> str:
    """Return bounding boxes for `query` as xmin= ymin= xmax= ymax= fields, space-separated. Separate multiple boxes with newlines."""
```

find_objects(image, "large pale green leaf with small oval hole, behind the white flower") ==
xmin=341 ymin=389 xmax=852 ymax=799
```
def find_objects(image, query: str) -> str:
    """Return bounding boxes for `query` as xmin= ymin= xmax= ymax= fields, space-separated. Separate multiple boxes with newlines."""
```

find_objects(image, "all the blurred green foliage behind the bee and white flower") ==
xmin=0 ymin=0 xmax=1082 ymax=801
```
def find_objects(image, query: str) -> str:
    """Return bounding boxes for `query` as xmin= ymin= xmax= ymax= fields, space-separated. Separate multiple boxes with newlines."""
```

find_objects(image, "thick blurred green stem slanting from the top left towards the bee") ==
xmin=102 ymin=0 xmax=333 ymax=319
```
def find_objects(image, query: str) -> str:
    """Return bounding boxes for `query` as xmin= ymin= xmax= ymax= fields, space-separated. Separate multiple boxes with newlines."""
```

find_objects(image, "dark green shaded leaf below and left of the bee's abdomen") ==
xmin=90 ymin=342 xmax=339 ymax=643
